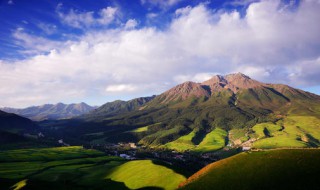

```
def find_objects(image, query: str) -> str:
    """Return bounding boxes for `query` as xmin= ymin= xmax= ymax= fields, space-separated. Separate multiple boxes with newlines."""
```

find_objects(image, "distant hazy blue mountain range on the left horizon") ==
xmin=1 ymin=103 xmax=96 ymax=121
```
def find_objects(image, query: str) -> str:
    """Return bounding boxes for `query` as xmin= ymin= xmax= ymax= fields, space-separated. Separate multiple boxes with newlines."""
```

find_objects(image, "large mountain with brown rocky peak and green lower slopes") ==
xmin=41 ymin=73 xmax=320 ymax=152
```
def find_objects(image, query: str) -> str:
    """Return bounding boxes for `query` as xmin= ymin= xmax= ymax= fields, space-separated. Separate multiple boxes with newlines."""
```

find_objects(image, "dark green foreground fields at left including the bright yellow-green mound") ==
xmin=0 ymin=147 xmax=186 ymax=189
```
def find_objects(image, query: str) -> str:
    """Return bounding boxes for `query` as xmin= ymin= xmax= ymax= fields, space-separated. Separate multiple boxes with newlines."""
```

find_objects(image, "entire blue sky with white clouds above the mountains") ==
xmin=0 ymin=0 xmax=320 ymax=107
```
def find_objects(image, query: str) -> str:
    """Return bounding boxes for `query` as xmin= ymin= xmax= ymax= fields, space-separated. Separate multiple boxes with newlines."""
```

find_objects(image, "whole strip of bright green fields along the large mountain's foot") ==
xmin=160 ymin=115 xmax=320 ymax=152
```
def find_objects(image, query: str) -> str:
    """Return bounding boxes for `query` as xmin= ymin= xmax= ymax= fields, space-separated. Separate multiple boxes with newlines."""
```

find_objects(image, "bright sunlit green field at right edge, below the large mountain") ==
xmin=252 ymin=116 xmax=320 ymax=149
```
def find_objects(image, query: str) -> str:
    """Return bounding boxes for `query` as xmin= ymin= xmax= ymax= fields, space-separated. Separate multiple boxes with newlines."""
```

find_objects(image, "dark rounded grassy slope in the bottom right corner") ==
xmin=180 ymin=149 xmax=320 ymax=190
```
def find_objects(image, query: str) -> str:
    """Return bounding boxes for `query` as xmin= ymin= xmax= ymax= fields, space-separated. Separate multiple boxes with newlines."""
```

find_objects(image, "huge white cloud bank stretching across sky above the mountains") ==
xmin=0 ymin=0 xmax=320 ymax=107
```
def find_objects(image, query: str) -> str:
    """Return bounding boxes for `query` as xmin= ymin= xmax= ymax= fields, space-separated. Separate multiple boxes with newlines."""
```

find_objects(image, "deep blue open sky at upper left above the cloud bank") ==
xmin=0 ymin=0 xmax=251 ymax=60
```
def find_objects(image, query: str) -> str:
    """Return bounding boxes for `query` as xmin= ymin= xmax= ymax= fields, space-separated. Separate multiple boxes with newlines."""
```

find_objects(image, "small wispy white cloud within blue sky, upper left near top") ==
xmin=57 ymin=4 xmax=117 ymax=28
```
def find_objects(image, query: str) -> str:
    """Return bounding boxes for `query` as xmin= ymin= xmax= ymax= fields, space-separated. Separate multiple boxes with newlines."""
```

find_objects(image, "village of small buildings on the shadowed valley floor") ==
xmin=84 ymin=142 xmax=243 ymax=172
